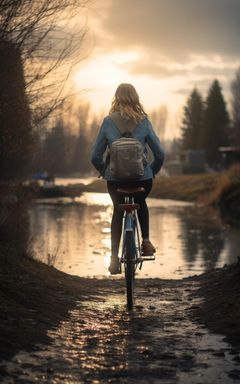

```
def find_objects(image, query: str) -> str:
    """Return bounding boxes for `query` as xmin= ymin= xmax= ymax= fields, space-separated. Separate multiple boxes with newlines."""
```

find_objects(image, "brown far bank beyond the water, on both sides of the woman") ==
xmin=32 ymin=167 xmax=240 ymax=223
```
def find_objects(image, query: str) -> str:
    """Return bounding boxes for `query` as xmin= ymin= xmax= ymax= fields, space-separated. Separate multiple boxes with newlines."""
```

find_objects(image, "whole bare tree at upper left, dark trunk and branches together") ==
xmin=0 ymin=0 xmax=91 ymax=179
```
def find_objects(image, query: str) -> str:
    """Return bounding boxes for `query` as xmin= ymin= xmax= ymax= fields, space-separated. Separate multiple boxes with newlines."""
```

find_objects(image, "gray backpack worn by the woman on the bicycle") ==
xmin=109 ymin=113 xmax=146 ymax=180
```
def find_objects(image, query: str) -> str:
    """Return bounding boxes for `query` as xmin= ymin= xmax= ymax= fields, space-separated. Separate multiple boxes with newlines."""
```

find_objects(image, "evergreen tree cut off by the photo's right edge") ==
xmin=230 ymin=68 xmax=240 ymax=145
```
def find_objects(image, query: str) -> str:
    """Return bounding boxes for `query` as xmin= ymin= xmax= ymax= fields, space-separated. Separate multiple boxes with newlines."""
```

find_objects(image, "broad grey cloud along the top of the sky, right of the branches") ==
xmin=99 ymin=0 xmax=240 ymax=62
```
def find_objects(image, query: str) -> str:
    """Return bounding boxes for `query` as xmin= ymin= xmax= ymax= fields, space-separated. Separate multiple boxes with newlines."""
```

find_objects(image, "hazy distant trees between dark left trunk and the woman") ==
xmin=32 ymin=105 xmax=101 ymax=175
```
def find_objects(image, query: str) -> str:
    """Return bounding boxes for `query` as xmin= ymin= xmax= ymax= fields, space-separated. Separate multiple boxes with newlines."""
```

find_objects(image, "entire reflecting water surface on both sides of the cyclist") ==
xmin=30 ymin=193 xmax=240 ymax=278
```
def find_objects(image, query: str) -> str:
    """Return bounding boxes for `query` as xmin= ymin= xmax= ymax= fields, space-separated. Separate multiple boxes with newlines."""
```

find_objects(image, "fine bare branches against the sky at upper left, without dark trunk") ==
xmin=0 ymin=0 xmax=91 ymax=124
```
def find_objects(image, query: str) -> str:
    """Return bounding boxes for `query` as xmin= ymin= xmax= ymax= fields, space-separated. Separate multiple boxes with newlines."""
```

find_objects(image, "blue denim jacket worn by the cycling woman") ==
xmin=91 ymin=116 xmax=164 ymax=181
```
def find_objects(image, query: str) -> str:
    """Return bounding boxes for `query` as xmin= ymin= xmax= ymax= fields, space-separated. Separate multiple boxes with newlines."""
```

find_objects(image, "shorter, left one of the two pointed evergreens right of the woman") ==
xmin=181 ymin=88 xmax=204 ymax=149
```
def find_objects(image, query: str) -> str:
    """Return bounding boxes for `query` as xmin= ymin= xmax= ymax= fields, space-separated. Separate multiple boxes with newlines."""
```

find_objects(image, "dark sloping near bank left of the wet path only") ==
xmin=0 ymin=249 xmax=100 ymax=360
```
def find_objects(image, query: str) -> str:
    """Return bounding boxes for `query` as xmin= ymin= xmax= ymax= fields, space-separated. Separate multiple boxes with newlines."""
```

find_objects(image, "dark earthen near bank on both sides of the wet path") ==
xmin=0 ymin=246 xmax=240 ymax=366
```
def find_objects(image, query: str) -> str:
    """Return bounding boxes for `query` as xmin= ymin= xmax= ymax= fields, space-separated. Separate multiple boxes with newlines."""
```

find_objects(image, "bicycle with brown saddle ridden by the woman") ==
xmin=117 ymin=187 xmax=155 ymax=309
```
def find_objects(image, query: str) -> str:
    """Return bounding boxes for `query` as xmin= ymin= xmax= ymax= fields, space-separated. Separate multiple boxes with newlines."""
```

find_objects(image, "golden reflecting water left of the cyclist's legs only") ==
xmin=30 ymin=203 xmax=111 ymax=276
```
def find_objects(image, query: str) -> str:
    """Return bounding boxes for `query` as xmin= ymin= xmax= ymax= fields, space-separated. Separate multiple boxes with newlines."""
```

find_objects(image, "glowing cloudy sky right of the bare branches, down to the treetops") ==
xmin=73 ymin=0 xmax=240 ymax=138
